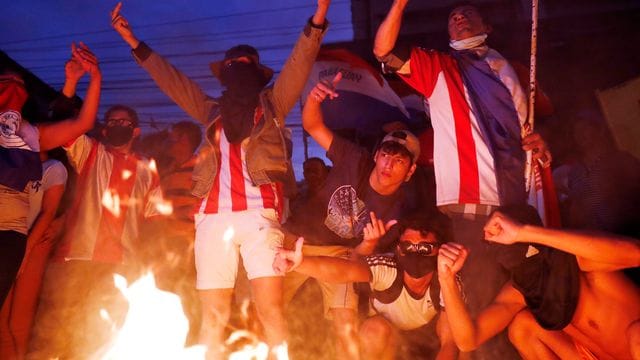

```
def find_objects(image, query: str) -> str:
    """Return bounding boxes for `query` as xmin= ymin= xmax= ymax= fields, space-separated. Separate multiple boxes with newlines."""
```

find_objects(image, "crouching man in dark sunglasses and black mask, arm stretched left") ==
xmin=274 ymin=214 xmax=458 ymax=359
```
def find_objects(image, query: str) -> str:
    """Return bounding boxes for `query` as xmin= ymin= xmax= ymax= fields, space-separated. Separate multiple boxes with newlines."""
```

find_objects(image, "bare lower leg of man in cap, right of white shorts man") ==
xmin=329 ymin=308 xmax=360 ymax=359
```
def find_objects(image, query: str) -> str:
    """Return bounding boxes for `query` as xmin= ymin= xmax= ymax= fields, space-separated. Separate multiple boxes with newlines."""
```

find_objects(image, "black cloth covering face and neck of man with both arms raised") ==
xmin=220 ymin=61 xmax=266 ymax=144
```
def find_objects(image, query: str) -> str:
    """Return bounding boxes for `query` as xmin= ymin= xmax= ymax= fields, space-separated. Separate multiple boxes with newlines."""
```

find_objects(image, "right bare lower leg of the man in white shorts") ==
xmin=250 ymin=276 xmax=287 ymax=348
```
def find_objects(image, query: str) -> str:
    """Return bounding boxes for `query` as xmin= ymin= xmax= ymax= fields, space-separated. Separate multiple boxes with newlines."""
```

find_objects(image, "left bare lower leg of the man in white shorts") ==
xmin=198 ymin=289 xmax=233 ymax=360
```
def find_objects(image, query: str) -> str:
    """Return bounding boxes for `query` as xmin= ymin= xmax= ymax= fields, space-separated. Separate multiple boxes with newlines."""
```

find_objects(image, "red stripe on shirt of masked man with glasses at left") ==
xmin=93 ymin=153 xmax=138 ymax=262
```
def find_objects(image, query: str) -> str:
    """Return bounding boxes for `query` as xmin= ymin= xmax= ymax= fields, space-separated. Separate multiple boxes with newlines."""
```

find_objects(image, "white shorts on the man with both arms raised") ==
xmin=195 ymin=209 xmax=284 ymax=290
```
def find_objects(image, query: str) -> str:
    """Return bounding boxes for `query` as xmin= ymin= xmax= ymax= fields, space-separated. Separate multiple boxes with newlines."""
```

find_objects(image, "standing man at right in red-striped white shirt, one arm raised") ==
xmin=373 ymin=0 xmax=552 ymax=357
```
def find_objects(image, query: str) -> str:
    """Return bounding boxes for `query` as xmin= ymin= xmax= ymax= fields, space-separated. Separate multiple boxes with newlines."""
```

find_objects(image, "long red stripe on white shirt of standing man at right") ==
xmin=445 ymin=59 xmax=480 ymax=204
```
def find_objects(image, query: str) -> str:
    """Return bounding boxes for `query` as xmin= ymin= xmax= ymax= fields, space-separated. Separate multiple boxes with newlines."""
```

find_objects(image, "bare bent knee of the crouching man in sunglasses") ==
xmin=360 ymin=315 xmax=398 ymax=360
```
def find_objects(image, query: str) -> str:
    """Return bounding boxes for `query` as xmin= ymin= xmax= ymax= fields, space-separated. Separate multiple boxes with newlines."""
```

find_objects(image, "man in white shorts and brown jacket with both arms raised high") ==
xmin=111 ymin=0 xmax=330 ymax=357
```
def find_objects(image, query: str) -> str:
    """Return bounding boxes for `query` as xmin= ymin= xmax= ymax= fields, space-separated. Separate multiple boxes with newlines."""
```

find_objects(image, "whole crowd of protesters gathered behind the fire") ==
xmin=0 ymin=0 xmax=640 ymax=359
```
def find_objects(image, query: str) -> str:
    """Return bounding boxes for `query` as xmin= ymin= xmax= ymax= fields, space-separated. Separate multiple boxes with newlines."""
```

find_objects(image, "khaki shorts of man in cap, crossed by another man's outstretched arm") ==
xmin=284 ymin=233 xmax=358 ymax=320
